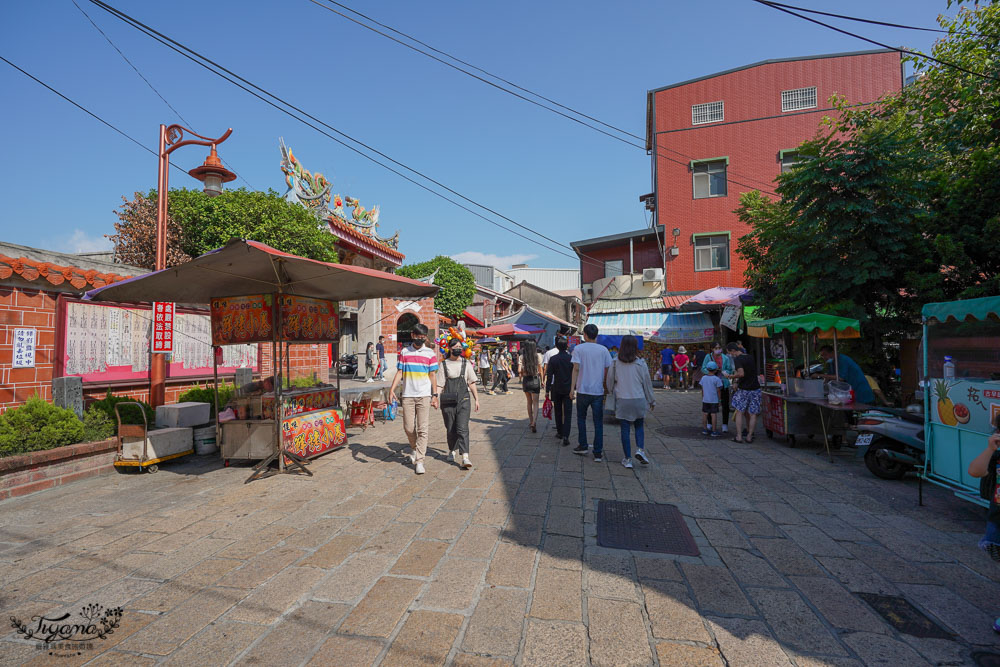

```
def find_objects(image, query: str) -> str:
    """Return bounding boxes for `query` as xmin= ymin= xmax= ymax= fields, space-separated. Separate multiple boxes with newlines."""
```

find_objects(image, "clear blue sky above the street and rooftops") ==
xmin=0 ymin=0 xmax=954 ymax=266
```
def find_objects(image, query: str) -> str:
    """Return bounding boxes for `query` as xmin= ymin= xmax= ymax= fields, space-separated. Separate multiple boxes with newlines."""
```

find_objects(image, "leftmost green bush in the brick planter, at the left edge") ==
xmin=0 ymin=396 xmax=84 ymax=456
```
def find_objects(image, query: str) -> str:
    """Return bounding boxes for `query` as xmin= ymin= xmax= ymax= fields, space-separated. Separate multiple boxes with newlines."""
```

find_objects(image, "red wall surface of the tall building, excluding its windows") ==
xmin=652 ymin=48 xmax=902 ymax=291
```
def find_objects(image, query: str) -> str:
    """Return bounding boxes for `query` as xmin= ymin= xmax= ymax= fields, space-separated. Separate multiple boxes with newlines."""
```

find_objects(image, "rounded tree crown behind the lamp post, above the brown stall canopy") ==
xmin=110 ymin=188 xmax=337 ymax=268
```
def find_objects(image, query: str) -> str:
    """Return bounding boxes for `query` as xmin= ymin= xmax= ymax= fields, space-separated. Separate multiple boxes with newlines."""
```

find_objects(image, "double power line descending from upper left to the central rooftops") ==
xmin=88 ymin=0 xmax=620 ymax=266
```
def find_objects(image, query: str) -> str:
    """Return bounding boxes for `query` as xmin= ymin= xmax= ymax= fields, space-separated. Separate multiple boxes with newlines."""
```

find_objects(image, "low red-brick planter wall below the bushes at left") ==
xmin=0 ymin=439 xmax=118 ymax=500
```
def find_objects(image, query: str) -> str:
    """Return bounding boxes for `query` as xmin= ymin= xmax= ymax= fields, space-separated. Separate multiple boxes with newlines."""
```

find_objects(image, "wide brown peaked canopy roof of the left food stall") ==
xmin=84 ymin=239 xmax=438 ymax=304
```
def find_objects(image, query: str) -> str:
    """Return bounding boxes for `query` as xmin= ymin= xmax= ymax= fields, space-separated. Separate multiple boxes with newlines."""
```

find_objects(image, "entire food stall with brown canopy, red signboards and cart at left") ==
xmin=85 ymin=239 xmax=438 ymax=482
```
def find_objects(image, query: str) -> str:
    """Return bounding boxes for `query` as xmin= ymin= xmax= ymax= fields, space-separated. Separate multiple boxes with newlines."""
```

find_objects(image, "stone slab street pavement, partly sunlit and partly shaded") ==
xmin=0 ymin=386 xmax=1000 ymax=666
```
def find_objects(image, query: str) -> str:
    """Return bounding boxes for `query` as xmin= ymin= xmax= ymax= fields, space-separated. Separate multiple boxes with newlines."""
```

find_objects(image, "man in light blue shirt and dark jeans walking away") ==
xmin=569 ymin=324 xmax=611 ymax=463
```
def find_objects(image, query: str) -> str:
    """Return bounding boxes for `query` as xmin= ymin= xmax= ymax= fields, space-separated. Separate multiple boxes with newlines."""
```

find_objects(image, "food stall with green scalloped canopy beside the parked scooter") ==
xmin=747 ymin=313 xmax=871 ymax=461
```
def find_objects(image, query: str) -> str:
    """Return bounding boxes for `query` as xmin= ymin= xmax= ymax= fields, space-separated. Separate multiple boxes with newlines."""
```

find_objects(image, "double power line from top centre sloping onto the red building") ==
xmin=309 ymin=0 xmax=777 ymax=196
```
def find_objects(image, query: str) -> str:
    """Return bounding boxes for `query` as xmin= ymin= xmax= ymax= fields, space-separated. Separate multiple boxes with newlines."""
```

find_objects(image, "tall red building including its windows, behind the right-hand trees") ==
xmin=648 ymin=50 xmax=903 ymax=292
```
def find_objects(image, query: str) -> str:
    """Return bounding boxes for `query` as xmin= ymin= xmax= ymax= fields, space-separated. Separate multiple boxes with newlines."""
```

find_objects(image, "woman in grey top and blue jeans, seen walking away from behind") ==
xmin=605 ymin=336 xmax=656 ymax=468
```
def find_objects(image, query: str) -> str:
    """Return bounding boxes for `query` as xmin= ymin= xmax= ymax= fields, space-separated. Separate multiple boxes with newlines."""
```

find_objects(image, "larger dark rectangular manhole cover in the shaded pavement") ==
xmin=597 ymin=500 xmax=700 ymax=556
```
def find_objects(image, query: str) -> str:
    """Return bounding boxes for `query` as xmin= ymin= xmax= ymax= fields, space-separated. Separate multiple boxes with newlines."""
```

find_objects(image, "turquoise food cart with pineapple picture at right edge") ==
xmin=921 ymin=296 xmax=1000 ymax=505
